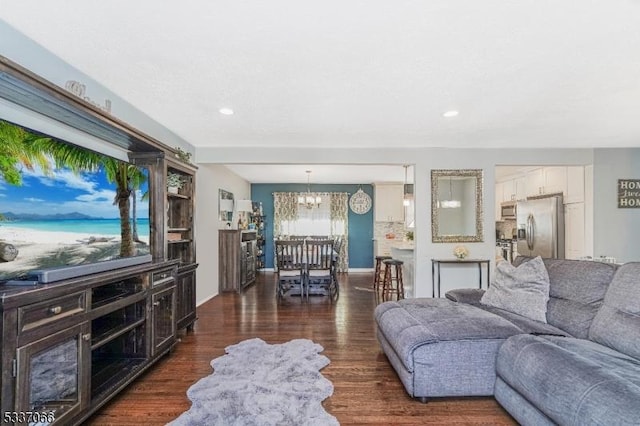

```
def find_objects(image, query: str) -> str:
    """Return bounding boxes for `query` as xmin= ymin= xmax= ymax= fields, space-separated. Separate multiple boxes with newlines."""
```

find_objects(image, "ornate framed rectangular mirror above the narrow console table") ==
xmin=431 ymin=169 xmax=484 ymax=243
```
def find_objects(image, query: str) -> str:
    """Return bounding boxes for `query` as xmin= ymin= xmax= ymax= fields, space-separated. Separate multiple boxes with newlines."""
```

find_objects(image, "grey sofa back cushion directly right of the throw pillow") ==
xmin=514 ymin=256 xmax=618 ymax=339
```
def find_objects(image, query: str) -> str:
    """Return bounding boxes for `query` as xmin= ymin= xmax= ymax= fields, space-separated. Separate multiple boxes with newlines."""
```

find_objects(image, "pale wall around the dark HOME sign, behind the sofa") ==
xmin=593 ymin=148 xmax=640 ymax=262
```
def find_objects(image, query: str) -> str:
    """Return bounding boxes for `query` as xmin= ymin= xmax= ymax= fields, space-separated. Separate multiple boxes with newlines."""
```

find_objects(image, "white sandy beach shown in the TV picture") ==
xmin=0 ymin=224 xmax=149 ymax=280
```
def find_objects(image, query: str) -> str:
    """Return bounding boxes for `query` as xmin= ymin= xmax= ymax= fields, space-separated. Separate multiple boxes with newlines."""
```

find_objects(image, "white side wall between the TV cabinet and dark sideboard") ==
xmin=195 ymin=164 xmax=251 ymax=305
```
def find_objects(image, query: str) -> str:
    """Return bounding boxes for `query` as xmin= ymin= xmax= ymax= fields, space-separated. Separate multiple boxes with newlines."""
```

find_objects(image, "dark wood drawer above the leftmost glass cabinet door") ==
xmin=18 ymin=292 xmax=86 ymax=333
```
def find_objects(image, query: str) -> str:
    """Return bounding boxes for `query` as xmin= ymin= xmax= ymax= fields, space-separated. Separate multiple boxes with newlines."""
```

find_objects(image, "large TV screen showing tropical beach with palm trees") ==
xmin=0 ymin=120 xmax=150 ymax=282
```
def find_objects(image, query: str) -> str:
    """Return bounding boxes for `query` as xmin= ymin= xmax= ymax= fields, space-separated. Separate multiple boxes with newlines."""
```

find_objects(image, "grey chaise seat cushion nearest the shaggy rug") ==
xmin=374 ymin=298 xmax=522 ymax=372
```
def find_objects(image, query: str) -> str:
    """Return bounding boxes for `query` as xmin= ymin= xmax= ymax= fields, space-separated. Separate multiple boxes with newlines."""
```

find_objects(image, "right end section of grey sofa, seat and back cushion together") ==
xmin=495 ymin=263 xmax=640 ymax=425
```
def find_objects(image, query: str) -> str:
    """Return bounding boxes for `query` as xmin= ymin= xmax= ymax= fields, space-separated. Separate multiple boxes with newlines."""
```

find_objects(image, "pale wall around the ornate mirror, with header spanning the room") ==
xmin=195 ymin=146 xmax=593 ymax=297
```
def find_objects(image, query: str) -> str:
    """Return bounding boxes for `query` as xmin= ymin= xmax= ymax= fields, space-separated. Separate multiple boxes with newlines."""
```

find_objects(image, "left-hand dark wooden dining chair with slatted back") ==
xmin=275 ymin=240 xmax=305 ymax=300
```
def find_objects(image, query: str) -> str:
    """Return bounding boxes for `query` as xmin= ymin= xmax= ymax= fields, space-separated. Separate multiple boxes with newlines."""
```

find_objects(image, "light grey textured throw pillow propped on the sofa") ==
xmin=480 ymin=256 xmax=549 ymax=323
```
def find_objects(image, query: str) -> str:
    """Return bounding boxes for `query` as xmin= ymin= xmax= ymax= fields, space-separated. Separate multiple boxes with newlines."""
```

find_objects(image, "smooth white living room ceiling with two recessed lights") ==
xmin=0 ymin=0 xmax=640 ymax=182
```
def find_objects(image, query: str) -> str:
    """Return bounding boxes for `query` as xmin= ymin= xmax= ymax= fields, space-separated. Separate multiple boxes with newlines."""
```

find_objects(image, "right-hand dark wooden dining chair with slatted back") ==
xmin=305 ymin=239 xmax=337 ymax=298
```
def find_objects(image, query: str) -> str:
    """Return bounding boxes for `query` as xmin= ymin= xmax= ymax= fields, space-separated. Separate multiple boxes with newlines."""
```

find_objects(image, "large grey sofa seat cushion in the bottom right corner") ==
xmin=496 ymin=334 xmax=640 ymax=425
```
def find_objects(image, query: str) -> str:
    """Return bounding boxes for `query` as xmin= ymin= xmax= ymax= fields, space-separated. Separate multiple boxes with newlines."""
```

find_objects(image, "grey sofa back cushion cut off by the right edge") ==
xmin=589 ymin=262 xmax=640 ymax=360
